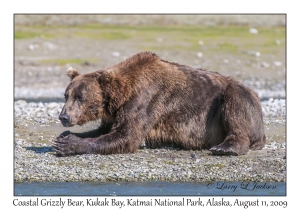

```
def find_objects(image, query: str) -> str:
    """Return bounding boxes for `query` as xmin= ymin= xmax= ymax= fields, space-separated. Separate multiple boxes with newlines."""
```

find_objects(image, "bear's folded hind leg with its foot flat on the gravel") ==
xmin=210 ymin=82 xmax=260 ymax=155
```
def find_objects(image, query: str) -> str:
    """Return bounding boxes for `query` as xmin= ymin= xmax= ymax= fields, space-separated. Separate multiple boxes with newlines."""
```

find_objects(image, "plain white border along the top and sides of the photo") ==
xmin=0 ymin=0 xmax=300 ymax=209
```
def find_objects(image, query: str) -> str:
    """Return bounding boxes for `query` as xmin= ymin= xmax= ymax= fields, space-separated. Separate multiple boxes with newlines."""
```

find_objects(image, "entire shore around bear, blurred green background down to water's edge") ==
xmin=14 ymin=15 xmax=286 ymax=182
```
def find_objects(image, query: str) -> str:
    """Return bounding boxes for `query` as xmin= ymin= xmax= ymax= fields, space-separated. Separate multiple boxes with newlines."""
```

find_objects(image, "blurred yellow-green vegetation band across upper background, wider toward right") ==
xmin=14 ymin=24 xmax=286 ymax=54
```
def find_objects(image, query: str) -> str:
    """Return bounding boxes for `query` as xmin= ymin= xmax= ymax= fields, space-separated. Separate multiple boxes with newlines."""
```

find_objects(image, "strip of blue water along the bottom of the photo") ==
xmin=14 ymin=181 xmax=286 ymax=196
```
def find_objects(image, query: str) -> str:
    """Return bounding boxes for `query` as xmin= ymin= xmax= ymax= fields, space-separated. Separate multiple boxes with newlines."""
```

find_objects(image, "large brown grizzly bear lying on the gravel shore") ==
xmin=53 ymin=52 xmax=266 ymax=156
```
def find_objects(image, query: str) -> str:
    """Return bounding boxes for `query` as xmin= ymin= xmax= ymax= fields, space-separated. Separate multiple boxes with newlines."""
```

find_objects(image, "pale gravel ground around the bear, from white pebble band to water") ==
xmin=14 ymin=99 xmax=286 ymax=182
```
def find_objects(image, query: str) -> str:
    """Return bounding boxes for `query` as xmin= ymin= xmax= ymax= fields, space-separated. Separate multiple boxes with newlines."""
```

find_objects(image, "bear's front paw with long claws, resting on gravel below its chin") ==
xmin=53 ymin=134 xmax=82 ymax=157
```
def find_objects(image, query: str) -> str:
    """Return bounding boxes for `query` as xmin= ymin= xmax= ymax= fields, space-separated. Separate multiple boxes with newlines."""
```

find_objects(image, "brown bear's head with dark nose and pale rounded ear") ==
xmin=59 ymin=67 xmax=104 ymax=127
